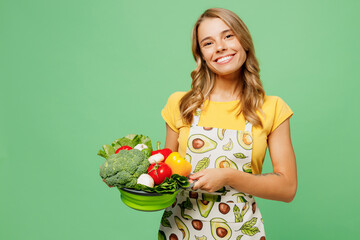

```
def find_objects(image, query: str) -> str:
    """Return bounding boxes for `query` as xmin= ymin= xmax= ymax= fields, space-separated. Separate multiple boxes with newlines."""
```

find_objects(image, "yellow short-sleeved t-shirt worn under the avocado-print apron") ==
xmin=161 ymin=92 xmax=293 ymax=174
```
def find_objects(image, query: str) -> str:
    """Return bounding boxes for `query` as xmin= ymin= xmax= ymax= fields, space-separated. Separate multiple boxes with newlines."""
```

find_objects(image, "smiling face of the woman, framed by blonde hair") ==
xmin=198 ymin=18 xmax=246 ymax=77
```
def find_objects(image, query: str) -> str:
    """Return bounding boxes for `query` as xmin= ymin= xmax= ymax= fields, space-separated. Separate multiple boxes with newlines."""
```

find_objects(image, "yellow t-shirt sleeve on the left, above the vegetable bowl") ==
xmin=161 ymin=92 xmax=184 ymax=133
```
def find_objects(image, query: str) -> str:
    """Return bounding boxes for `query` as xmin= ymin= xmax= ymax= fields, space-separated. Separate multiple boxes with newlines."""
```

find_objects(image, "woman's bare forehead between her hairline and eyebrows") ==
xmin=198 ymin=18 xmax=231 ymax=41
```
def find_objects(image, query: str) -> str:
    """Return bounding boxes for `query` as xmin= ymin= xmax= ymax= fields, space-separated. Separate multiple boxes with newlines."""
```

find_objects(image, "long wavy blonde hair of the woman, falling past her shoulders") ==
xmin=180 ymin=8 xmax=265 ymax=127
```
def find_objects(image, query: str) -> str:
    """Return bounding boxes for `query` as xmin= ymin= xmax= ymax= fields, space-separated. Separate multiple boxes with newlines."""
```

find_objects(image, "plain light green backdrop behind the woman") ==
xmin=0 ymin=0 xmax=360 ymax=240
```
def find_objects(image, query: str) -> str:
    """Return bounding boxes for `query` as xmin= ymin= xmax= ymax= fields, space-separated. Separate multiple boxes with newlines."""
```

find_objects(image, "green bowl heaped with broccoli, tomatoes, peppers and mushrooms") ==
xmin=98 ymin=134 xmax=191 ymax=211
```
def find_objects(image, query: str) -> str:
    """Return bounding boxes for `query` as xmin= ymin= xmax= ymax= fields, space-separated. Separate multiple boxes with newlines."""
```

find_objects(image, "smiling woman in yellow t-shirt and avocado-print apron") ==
xmin=159 ymin=8 xmax=297 ymax=240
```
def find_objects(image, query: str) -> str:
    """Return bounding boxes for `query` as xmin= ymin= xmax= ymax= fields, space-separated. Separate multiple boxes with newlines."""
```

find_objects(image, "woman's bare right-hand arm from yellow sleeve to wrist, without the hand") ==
xmin=229 ymin=120 xmax=297 ymax=202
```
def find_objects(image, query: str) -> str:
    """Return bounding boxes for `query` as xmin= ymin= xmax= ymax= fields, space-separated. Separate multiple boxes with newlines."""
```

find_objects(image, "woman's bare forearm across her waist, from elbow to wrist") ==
xmin=226 ymin=169 xmax=297 ymax=202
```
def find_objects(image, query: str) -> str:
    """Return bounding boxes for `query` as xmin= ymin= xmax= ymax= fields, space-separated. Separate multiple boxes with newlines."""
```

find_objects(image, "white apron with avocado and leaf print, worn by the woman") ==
xmin=158 ymin=109 xmax=265 ymax=240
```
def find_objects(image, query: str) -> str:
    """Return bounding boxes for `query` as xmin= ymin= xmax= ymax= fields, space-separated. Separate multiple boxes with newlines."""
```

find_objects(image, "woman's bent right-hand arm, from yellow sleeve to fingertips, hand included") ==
xmin=191 ymin=120 xmax=297 ymax=202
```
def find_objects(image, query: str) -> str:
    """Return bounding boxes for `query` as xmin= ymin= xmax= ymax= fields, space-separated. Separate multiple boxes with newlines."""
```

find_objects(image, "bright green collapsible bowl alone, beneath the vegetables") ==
xmin=118 ymin=188 xmax=180 ymax=212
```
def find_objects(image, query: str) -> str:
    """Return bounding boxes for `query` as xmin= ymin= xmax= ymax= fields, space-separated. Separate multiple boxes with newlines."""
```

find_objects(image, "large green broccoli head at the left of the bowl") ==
xmin=100 ymin=149 xmax=150 ymax=188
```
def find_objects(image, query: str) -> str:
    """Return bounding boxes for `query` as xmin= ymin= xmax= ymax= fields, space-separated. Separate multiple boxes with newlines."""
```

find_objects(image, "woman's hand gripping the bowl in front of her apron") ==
xmin=189 ymin=168 xmax=230 ymax=192
